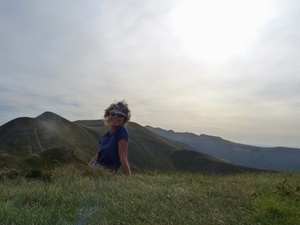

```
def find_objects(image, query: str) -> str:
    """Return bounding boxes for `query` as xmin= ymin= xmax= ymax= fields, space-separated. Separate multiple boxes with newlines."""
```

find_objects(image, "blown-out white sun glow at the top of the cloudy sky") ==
xmin=170 ymin=0 xmax=273 ymax=63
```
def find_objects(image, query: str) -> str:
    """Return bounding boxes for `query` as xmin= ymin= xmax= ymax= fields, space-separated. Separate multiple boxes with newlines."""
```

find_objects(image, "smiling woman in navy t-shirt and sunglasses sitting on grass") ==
xmin=89 ymin=100 xmax=131 ymax=176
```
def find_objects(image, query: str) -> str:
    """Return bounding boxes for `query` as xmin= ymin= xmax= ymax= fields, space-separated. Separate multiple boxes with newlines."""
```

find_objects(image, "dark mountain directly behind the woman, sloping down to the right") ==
xmin=75 ymin=120 xmax=258 ymax=174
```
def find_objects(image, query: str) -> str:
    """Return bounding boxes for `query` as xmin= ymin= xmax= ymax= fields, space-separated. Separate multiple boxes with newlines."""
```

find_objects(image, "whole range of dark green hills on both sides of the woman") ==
xmin=0 ymin=112 xmax=258 ymax=174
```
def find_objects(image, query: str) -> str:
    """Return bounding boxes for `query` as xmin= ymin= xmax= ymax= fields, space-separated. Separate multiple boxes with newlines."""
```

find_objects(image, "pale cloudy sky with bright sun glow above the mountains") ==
xmin=0 ymin=0 xmax=300 ymax=148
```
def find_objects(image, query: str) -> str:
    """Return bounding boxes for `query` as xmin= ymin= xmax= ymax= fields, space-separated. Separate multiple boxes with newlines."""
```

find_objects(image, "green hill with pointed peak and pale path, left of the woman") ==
xmin=0 ymin=112 xmax=98 ymax=161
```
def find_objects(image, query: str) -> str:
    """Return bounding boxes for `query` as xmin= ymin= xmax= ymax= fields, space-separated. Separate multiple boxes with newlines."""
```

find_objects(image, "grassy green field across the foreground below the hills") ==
xmin=0 ymin=166 xmax=300 ymax=225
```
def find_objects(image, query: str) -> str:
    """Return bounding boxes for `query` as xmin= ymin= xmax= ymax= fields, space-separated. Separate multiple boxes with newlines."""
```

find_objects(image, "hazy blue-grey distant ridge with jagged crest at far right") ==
xmin=146 ymin=126 xmax=300 ymax=171
